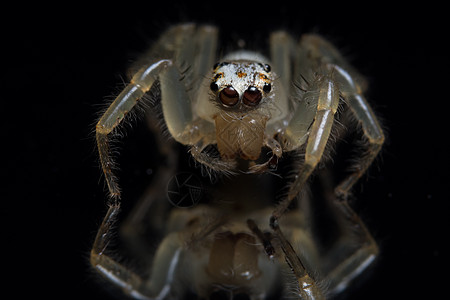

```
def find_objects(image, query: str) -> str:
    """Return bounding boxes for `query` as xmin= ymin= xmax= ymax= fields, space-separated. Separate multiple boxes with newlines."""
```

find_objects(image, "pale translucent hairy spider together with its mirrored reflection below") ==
xmin=91 ymin=24 xmax=384 ymax=299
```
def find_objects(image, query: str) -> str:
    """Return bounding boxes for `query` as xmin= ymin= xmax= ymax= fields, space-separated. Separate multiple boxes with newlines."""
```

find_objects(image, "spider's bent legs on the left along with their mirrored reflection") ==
xmin=94 ymin=24 xmax=221 ymax=299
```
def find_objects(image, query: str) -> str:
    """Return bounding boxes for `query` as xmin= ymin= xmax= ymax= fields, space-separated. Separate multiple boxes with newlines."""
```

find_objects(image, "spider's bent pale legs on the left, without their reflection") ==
xmin=96 ymin=24 xmax=217 ymax=199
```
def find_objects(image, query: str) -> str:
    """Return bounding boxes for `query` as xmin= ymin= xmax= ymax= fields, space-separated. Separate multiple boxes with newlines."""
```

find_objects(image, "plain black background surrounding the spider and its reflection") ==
xmin=4 ymin=1 xmax=450 ymax=299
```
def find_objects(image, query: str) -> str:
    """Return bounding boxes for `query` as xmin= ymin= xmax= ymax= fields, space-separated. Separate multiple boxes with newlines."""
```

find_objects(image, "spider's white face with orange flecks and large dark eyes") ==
xmin=210 ymin=61 xmax=272 ymax=109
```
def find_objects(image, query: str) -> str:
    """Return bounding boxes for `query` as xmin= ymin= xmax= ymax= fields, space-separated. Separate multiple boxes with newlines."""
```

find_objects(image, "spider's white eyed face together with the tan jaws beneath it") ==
xmin=210 ymin=59 xmax=274 ymax=160
